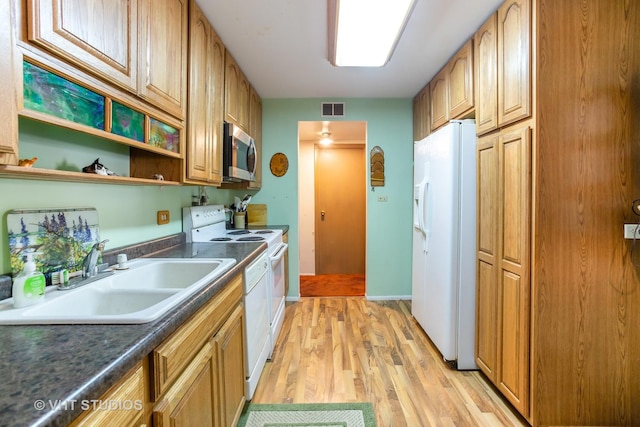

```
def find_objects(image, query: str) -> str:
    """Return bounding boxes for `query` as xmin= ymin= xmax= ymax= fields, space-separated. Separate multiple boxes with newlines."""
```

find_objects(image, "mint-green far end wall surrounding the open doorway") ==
xmin=252 ymin=98 xmax=413 ymax=299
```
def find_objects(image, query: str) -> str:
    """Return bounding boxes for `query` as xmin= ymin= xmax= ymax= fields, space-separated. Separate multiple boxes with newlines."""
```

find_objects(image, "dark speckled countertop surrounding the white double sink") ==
xmin=0 ymin=243 xmax=267 ymax=426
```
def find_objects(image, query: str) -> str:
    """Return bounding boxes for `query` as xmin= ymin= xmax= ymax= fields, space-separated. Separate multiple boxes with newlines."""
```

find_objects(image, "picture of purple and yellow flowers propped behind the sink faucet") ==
xmin=7 ymin=208 xmax=100 ymax=285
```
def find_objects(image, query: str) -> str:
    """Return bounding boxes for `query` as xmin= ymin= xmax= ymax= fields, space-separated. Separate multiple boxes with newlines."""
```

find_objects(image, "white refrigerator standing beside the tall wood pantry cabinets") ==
xmin=411 ymin=120 xmax=477 ymax=370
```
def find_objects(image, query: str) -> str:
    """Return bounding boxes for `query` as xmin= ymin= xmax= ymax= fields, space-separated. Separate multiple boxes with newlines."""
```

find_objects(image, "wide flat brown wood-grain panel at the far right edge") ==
xmin=532 ymin=0 xmax=640 ymax=426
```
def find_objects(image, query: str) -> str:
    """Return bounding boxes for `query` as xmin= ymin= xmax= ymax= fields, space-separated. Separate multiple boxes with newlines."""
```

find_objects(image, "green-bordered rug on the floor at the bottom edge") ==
xmin=238 ymin=402 xmax=376 ymax=427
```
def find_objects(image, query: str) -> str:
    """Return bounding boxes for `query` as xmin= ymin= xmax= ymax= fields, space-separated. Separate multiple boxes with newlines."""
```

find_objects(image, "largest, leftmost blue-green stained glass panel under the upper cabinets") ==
xmin=23 ymin=61 xmax=105 ymax=130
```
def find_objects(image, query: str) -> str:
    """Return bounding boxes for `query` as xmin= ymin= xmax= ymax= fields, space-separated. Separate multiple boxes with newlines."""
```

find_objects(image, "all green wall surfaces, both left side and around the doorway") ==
xmin=0 ymin=99 xmax=413 ymax=298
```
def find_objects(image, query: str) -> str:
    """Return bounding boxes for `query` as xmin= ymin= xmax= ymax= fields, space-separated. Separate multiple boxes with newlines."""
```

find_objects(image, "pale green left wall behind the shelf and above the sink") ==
xmin=0 ymin=120 xmax=240 ymax=274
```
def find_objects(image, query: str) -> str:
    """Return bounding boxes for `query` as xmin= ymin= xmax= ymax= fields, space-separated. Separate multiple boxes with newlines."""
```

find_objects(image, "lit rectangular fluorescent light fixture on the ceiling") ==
xmin=328 ymin=0 xmax=416 ymax=67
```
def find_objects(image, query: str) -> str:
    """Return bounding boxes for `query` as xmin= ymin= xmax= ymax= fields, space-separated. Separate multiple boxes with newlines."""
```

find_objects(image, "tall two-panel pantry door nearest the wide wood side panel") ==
xmin=497 ymin=127 xmax=531 ymax=416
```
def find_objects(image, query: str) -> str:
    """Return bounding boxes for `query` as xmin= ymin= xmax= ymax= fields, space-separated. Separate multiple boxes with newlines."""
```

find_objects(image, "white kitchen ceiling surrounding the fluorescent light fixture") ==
xmin=196 ymin=0 xmax=503 ymax=98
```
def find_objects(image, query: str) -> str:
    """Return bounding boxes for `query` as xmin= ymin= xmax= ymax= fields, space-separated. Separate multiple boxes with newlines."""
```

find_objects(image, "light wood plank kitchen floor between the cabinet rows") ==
xmin=252 ymin=297 xmax=527 ymax=427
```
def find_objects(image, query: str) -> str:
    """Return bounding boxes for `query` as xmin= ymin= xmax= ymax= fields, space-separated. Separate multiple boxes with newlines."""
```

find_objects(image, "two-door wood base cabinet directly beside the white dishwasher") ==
xmin=150 ymin=274 xmax=246 ymax=426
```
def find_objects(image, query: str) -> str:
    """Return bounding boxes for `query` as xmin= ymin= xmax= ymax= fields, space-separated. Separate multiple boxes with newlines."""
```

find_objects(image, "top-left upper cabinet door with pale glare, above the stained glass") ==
xmin=28 ymin=0 xmax=138 ymax=93
